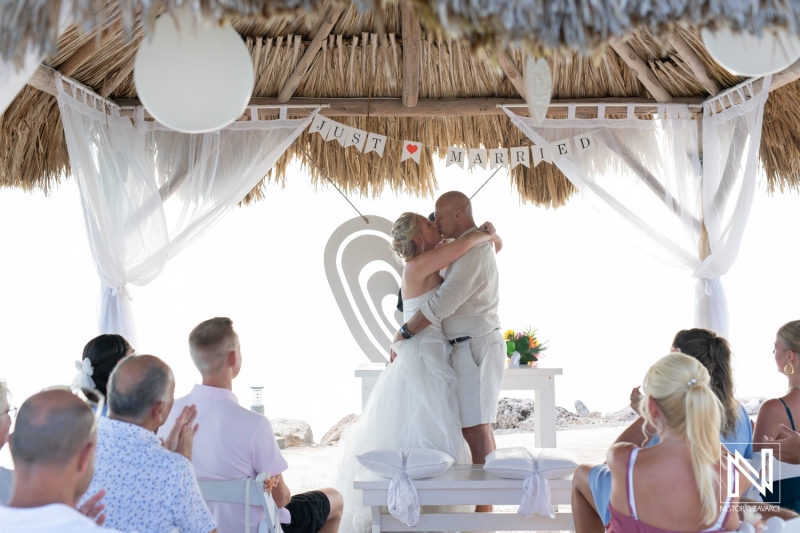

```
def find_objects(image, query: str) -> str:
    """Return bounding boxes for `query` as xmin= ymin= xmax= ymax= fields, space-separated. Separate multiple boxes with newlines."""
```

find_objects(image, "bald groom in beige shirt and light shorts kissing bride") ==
xmin=395 ymin=191 xmax=506 ymax=502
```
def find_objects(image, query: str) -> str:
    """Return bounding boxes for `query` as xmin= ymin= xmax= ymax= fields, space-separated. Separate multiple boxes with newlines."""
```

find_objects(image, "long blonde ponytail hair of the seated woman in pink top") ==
xmin=639 ymin=353 xmax=722 ymax=524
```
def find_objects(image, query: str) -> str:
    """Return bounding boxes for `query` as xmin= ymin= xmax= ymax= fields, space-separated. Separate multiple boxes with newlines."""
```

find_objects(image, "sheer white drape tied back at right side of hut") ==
xmin=506 ymin=79 xmax=770 ymax=336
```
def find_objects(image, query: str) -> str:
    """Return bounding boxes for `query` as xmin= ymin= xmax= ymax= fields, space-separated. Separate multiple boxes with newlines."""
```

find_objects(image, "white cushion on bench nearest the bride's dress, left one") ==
xmin=356 ymin=448 xmax=454 ymax=479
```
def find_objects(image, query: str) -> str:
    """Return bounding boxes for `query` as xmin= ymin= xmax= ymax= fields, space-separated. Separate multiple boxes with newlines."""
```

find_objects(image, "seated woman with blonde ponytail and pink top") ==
xmin=608 ymin=353 xmax=744 ymax=533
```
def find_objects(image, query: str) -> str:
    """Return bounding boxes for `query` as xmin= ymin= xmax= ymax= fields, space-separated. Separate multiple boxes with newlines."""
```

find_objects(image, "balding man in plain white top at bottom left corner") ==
xmin=0 ymin=390 xmax=121 ymax=533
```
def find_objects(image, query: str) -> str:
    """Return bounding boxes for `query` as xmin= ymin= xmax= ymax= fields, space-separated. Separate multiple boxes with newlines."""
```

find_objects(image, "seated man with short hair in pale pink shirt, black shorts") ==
xmin=159 ymin=318 xmax=343 ymax=533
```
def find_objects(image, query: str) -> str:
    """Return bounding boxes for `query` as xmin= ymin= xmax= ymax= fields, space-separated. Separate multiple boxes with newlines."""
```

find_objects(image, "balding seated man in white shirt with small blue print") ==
xmin=80 ymin=355 xmax=215 ymax=533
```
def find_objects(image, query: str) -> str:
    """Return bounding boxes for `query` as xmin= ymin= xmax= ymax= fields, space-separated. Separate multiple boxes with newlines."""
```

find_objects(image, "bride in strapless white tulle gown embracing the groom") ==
xmin=334 ymin=213 xmax=500 ymax=533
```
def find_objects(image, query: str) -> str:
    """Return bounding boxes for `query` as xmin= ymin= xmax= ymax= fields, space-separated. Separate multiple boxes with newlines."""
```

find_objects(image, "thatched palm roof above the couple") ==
xmin=0 ymin=0 xmax=800 ymax=206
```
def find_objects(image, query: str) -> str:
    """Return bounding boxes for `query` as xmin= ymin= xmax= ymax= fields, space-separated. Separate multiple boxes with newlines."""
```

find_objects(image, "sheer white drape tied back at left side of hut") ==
xmin=56 ymin=77 xmax=313 ymax=343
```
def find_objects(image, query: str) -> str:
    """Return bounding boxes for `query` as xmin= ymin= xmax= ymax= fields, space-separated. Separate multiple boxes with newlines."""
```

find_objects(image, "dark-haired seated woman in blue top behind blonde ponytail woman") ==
xmin=572 ymin=328 xmax=753 ymax=533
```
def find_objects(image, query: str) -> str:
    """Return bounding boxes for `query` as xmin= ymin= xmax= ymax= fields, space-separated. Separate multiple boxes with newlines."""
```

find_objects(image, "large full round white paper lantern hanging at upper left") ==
xmin=133 ymin=9 xmax=254 ymax=133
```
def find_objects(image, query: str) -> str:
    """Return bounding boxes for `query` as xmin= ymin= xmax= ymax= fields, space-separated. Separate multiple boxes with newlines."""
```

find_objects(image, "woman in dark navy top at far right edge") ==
xmin=753 ymin=320 xmax=800 ymax=512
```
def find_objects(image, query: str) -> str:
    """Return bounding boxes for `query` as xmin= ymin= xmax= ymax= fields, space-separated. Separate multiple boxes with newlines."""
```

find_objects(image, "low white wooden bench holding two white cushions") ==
xmin=354 ymin=465 xmax=575 ymax=533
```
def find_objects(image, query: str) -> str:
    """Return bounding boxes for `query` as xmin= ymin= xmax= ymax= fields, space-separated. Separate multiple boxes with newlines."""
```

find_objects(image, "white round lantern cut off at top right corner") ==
xmin=700 ymin=27 xmax=800 ymax=77
